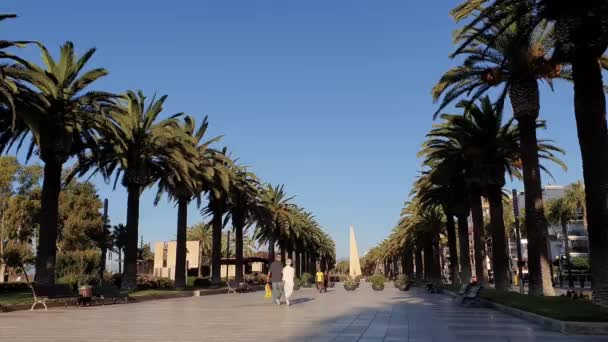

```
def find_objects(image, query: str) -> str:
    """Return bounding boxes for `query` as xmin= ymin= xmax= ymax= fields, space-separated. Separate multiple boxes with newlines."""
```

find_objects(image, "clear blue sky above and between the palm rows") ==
xmin=0 ymin=0 xmax=581 ymax=257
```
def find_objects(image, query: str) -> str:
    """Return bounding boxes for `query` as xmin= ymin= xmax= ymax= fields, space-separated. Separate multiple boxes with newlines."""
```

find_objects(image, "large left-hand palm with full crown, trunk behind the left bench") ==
xmin=7 ymin=42 xmax=114 ymax=284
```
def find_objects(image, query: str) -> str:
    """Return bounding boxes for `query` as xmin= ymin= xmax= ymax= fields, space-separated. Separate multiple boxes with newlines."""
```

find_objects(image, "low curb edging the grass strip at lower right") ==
xmin=442 ymin=290 xmax=608 ymax=335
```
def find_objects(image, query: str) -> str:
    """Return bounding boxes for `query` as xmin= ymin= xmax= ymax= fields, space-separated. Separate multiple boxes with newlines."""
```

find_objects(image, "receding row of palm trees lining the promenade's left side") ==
xmin=0 ymin=15 xmax=335 ymax=289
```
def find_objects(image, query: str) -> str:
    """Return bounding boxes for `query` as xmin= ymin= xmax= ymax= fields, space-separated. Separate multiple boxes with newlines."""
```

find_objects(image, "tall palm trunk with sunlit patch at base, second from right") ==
xmin=510 ymin=78 xmax=555 ymax=296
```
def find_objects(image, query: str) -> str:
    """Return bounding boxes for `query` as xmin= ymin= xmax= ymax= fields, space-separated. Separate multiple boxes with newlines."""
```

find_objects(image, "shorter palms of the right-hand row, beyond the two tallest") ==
xmin=364 ymin=96 xmax=565 ymax=289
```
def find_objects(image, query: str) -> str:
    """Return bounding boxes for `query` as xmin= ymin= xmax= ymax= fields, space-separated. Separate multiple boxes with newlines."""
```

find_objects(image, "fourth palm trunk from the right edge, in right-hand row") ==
xmin=471 ymin=185 xmax=490 ymax=284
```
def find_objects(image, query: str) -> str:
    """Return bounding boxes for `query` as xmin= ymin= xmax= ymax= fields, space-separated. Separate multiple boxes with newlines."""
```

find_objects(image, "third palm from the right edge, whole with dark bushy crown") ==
xmin=426 ymin=97 xmax=563 ymax=288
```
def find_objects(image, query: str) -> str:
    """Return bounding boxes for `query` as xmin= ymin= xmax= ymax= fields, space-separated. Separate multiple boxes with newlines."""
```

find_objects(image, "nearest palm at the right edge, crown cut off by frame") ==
xmin=454 ymin=0 xmax=608 ymax=305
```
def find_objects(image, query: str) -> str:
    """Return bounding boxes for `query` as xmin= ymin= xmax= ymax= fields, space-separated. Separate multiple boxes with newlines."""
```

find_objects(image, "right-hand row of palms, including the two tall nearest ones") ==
xmin=368 ymin=0 xmax=608 ymax=305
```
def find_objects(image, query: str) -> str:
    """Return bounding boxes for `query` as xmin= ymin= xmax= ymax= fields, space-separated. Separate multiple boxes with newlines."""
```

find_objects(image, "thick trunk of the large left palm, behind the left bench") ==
xmin=35 ymin=158 xmax=63 ymax=285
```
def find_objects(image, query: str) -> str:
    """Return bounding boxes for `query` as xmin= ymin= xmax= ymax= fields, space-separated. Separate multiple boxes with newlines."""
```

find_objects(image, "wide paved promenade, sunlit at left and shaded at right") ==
xmin=0 ymin=283 xmax=608 ymax=342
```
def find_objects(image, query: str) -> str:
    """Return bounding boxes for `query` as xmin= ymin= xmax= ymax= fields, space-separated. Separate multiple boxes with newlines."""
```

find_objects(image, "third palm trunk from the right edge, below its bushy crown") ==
xmin=488 ymin=185 xmax=510 ymax=290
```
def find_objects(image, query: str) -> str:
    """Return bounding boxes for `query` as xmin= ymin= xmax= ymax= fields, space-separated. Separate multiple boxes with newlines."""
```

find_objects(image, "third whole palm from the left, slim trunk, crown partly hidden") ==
xmin=154 ymin=116 xmax=219 ymax=288
